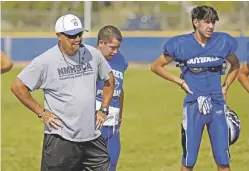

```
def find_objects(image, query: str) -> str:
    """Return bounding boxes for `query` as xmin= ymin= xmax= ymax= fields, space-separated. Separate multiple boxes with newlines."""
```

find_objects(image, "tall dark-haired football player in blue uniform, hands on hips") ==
xmin=151 ymin=6 xmax=240 ymax=171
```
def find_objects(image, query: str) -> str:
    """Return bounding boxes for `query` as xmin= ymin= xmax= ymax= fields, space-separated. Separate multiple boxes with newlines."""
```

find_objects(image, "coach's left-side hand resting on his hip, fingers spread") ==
xmin=38 ymin=110 xmax=61 ymax=129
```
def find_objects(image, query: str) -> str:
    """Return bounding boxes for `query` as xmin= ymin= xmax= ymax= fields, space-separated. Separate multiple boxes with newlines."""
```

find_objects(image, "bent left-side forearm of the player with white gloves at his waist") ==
xmin=151 ymin=66 xmax=184 ymax=85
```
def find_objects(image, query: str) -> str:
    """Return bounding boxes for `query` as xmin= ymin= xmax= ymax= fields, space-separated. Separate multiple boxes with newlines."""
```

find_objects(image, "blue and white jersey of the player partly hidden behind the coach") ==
xmin=96 ymin=52 xmax=128 ymax=108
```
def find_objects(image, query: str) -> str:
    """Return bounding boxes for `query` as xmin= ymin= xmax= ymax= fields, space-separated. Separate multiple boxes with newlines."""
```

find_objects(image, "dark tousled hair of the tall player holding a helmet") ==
xmin=191 ymin=5 xmax=219 ymax=29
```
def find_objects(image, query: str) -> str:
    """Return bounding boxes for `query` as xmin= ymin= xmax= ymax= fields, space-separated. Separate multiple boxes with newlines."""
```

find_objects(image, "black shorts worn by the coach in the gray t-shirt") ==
xmin=41 ymin=134 xmax=110 ymax=171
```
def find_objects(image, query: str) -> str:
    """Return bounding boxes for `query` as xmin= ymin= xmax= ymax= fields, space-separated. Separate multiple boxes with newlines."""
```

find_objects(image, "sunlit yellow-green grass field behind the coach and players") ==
xmin=1 ymin=68 xmax=249 ymax=171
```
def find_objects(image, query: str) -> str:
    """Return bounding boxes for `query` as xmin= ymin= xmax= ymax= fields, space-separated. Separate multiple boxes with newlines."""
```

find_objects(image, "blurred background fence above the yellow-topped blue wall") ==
xmin=1 ymin=2 xmax=249 ymax=32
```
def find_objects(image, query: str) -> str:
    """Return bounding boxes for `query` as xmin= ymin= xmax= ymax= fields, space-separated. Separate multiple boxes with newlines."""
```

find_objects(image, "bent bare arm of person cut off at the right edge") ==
xmin=238 ymin=56 xmax=249 ymax=93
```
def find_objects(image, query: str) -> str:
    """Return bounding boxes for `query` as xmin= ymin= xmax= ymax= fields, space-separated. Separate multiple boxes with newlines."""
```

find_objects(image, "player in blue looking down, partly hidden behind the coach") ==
xmin=96 ymin=25 xmax=128 ymax=171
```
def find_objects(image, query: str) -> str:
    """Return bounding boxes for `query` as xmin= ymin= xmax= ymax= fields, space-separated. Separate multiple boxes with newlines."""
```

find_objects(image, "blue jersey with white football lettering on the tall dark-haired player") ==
xmin=163 ymin=32 xmax=238 ymax=103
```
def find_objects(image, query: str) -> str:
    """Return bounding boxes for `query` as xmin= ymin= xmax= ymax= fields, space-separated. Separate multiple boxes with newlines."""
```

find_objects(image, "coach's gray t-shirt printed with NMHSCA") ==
xmin=17 ymin=45 xmax=111 ymax=142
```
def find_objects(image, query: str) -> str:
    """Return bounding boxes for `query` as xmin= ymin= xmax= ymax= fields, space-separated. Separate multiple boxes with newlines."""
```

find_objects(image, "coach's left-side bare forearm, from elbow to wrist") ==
xmin=11 ymin=79 xmax=43 ymax=115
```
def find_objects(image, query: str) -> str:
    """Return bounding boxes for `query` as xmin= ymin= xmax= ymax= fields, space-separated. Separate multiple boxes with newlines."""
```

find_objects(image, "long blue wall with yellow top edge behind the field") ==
xmin=1 ymin=37 xmax=249 ymax=62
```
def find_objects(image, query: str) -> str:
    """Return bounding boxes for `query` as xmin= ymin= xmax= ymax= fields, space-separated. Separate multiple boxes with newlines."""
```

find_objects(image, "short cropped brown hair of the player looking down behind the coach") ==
xmin=97 ymin=25 xmax=123 ymax=44
